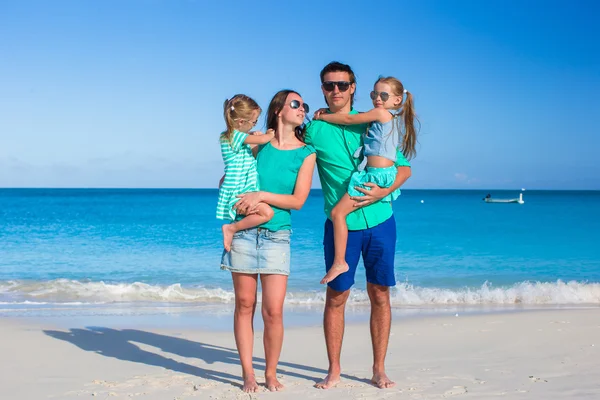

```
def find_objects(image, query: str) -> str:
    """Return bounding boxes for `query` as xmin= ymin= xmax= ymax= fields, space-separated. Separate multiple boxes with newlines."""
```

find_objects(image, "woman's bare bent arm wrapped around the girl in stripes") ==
xmin=235 ymin=153 xmax=317 ymax=215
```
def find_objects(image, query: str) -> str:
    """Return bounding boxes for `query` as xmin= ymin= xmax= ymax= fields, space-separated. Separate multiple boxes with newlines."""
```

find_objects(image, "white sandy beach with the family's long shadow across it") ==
xmin=0 ymin=308 xmax=600 ymax=400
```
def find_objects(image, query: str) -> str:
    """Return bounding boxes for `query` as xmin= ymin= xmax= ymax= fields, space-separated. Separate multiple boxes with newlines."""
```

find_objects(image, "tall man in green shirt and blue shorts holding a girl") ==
xmin=306 ymin=62 xmax=411 ymax=389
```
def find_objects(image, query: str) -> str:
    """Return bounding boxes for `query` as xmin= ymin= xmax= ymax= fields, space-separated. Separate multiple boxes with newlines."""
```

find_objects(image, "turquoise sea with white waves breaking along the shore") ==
xmin=0 ymin=189 xmax=600 ymax=312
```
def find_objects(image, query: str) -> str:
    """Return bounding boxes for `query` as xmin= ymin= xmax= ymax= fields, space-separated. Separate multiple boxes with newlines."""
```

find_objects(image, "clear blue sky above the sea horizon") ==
xmin=0 ymin=0 xmax=600 ymax=189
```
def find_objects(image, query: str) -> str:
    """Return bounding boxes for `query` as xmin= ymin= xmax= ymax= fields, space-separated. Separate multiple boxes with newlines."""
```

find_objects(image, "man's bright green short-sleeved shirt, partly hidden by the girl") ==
xmin=308 ymin=109 xmax=410 ymax=231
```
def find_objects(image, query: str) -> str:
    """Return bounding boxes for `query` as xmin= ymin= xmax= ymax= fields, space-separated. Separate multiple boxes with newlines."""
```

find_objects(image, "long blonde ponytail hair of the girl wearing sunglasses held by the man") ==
xmin=375 ymin=76 xmax=420 ymax=160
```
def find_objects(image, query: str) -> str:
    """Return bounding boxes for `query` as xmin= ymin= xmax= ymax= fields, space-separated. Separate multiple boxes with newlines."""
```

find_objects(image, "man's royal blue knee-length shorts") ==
xmin=323 ymin=215 xmax=396 ymax=292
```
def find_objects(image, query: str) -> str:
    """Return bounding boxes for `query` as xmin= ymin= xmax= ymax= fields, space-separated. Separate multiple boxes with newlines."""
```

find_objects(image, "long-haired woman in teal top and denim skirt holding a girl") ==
xmin=221 ymin=90 xmax=316 ymax=392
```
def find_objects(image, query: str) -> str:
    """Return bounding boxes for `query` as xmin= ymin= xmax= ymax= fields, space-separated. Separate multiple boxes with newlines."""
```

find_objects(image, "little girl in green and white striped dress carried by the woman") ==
xmin=217 ymin=94 xmax=274 ymax=251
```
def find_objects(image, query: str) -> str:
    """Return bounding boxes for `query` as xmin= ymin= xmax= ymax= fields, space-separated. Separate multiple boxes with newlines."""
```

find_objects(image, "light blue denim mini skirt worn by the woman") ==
xmin=221 ymin=228 xmax=291 ymax=275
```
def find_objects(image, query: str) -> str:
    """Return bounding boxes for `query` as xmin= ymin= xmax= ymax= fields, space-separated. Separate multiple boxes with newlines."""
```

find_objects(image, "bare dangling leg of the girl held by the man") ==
xmin=321 ymin=193 xmax=354 ymax=284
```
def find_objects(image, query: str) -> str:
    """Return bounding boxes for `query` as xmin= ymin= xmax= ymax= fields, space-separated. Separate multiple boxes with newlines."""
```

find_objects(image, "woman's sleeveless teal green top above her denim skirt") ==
xmin=256 ymin=143 xmax=315 ymax=231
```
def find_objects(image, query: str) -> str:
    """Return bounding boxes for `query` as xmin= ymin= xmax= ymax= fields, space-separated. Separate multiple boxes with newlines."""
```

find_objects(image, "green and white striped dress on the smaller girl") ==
xmin=217 ymin=130 xmax=258 ymax=221
